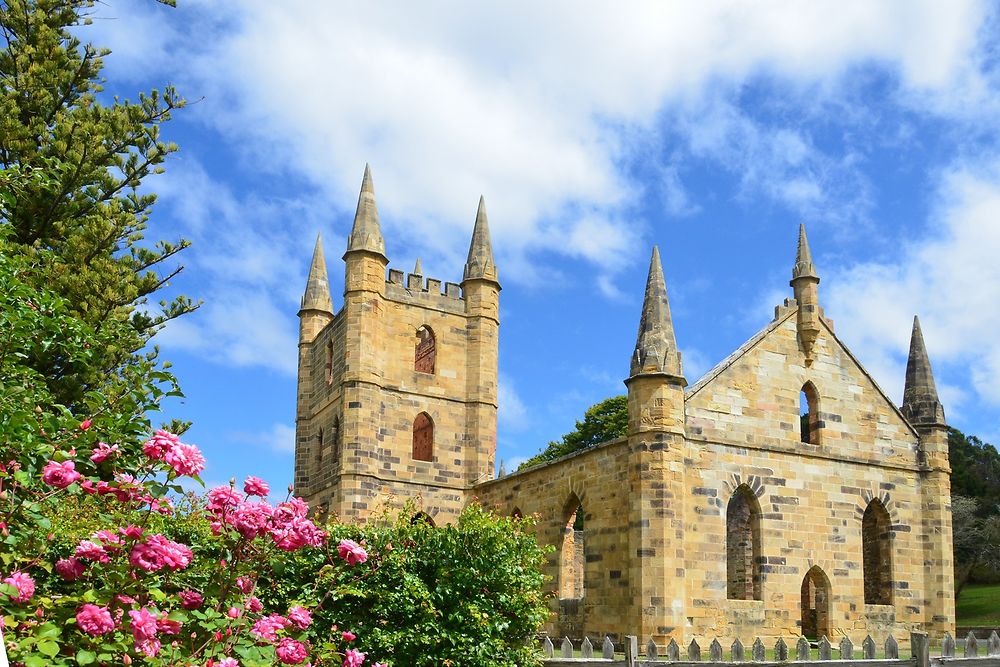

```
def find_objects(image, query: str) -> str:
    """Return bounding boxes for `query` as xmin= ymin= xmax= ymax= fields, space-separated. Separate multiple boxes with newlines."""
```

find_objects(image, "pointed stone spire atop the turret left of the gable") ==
xmin=630 ymin=246 xmax=683 ymax=377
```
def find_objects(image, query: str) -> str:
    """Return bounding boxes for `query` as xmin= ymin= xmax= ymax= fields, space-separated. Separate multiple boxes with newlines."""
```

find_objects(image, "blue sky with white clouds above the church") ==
xmin=80 ymin=0 xmax=1000 ymax=486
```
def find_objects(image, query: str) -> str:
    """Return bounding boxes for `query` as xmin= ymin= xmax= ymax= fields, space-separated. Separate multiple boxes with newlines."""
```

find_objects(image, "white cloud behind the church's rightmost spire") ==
xmin=825 ymin=163 xmax=1000 ymax=414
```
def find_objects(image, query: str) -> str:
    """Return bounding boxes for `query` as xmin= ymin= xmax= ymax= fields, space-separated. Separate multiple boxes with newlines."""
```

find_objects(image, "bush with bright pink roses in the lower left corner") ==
xmin=0 ymin=245 xmax=388 ymax=667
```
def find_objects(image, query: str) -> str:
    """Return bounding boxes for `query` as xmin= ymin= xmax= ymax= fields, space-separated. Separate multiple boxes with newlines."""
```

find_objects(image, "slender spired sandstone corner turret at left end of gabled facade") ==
xmin=625 ymin=247 xmax=687 ymax=636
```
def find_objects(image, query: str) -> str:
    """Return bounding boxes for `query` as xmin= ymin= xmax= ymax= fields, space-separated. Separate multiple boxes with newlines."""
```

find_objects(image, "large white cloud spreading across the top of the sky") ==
xmin=94 ymin=0 xmax=993 ymax=284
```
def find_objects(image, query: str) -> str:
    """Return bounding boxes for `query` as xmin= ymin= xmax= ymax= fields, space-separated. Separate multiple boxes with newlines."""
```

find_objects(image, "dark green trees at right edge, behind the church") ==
xmin=948 ymin=428 xmax=1000 ymax=516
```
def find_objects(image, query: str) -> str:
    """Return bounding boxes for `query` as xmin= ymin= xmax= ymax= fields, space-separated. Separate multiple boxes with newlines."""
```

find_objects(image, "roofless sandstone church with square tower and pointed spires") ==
xmin=295 ymin=168 xmax=955 ymax=646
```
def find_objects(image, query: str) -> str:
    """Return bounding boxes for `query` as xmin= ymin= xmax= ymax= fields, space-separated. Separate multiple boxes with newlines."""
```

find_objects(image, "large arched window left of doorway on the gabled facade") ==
xmin=726 ymin=484 xmax=764 ymax=600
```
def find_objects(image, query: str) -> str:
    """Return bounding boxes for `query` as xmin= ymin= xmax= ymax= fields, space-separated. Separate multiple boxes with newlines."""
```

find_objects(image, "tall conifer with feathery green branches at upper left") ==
xmin=0 ymin=0 xmax=196 ymax=407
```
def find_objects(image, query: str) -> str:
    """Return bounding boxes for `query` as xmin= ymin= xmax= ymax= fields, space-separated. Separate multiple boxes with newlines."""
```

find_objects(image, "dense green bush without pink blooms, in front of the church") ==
xmin=270 ymin=504 xmax=549 ymax=667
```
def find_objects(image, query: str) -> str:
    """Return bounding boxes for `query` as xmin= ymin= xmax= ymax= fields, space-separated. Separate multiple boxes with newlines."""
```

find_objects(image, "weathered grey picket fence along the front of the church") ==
xmin=542 ymin=630 xmax=1000 ymax=667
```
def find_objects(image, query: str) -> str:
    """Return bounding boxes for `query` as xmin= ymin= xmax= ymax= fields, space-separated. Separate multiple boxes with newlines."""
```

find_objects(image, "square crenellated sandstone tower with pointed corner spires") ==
xmin=295 ymin=166 xmax=500 ymax=523
